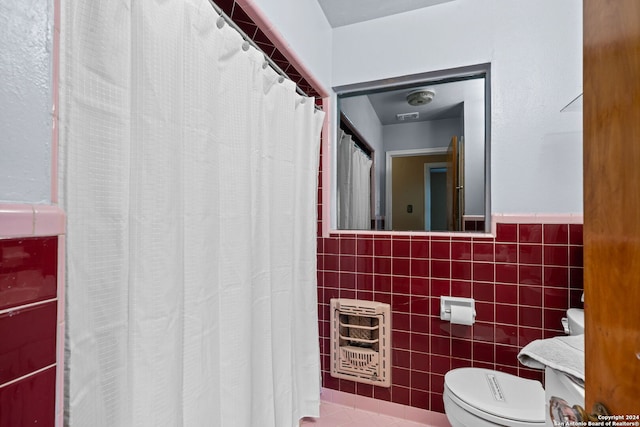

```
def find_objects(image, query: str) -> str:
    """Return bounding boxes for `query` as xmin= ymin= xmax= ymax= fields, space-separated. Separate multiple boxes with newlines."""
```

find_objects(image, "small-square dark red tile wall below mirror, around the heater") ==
xmin=318 ymin=223 xmax=582 ymax=412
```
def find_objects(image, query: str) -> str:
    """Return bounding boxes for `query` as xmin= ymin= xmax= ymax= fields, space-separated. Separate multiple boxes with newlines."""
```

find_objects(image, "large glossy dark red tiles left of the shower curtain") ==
xmin=0 ymin=237 xmax=58 ymax=427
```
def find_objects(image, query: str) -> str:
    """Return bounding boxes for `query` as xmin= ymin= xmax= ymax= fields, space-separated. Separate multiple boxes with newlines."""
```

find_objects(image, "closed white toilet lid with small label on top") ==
xmin=444 ymin=368 xmax=545 ymax=423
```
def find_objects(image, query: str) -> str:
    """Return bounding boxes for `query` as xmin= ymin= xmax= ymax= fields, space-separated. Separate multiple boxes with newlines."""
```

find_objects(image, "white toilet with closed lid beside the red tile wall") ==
xmin=443 ymin=312 xmax=584 ymax=427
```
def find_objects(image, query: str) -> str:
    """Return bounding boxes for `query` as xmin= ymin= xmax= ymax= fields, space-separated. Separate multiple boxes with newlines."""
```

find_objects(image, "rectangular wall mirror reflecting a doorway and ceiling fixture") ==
xmin=334 ymin=64 xmax=491 ymax=233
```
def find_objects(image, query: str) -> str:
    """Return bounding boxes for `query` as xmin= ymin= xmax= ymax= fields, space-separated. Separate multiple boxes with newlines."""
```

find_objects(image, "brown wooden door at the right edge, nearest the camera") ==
xmin=583 ymin=0 xmax=640 ymax=414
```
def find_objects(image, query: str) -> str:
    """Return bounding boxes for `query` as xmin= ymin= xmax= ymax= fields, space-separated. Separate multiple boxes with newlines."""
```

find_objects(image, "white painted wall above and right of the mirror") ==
xmin=331 ymin=0 xmax=582 ymax=214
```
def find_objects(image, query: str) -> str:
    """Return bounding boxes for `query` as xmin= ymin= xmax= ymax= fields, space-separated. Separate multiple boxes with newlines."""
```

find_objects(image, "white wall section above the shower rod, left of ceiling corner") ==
xmin=251 ymin=0 xmax=332 ymax=91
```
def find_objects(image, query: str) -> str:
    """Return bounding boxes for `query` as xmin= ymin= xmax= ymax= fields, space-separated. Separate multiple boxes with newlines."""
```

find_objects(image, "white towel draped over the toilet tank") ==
xmin=518 ymin=335 xmax=584 ymax=383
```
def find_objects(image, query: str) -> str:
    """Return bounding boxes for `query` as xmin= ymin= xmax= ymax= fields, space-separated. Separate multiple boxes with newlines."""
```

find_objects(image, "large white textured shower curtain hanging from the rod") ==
xmin=60 ymin=0 xmax=323 ymax=427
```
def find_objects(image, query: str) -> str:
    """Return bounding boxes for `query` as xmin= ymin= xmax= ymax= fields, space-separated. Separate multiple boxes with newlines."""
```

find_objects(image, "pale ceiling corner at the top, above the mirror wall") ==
xmin=318 ymin=0 xmax=453 ymax=28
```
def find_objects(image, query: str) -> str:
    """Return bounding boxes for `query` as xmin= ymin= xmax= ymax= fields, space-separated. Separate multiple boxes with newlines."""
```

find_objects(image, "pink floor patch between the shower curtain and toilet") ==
xmin=300 ymin=401 xmax=448 ymax=427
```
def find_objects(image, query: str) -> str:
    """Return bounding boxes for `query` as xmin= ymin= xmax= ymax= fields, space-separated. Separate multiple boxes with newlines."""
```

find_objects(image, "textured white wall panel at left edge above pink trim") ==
xmin=0 ymin=0 xmax=53 ymax=203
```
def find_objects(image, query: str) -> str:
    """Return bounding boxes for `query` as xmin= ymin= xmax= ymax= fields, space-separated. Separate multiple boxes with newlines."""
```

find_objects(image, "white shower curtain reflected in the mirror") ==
xmin=337 ymin=131 xmax=372 ymax=230
